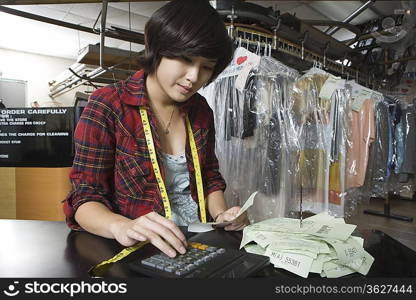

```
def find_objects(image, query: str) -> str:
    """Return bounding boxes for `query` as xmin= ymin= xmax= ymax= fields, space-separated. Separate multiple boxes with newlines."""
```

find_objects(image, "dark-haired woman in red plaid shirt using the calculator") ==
xmin=64 ymin=0 xmax=248 ymax=257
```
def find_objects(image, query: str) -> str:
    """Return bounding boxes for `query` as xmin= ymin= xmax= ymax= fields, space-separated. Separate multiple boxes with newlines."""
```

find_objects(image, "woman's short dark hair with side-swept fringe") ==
xmin=142 ymin=0 xmax=233 ymax=82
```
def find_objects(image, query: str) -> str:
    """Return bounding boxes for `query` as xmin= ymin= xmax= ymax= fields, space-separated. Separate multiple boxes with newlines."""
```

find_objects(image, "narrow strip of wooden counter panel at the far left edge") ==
xmin=0 ymin=168 xmax=16 ymax=219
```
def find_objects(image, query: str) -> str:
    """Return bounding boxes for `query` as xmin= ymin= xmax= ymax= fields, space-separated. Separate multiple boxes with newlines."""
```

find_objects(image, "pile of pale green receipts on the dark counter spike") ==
xmin=240 ymin=213 xmax=374 ymax=278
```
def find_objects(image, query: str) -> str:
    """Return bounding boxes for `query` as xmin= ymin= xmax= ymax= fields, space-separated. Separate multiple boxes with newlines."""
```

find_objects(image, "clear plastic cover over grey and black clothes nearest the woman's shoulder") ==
xmin=203 ymin=56 xmax=299 ymax=221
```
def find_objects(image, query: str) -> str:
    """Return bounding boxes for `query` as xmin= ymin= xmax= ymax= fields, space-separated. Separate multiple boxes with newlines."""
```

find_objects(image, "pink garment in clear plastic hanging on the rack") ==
xmin=347 ymin=99 xmax=375 ymax=188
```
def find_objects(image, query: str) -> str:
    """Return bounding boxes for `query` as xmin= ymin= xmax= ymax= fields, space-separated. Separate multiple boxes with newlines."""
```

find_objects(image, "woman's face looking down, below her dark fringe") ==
xmin=155 ymin=56 xmax=216 ymax=102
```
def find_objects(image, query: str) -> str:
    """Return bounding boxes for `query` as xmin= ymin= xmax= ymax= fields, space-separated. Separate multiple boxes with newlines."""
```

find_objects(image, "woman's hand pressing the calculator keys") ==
xmin=111 ymin=212 xmax=187 ymax=257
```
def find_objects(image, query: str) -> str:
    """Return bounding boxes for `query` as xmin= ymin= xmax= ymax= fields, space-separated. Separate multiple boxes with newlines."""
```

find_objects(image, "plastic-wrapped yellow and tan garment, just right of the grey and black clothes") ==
xmin=292 ymin=70 xmax=330 ymax=213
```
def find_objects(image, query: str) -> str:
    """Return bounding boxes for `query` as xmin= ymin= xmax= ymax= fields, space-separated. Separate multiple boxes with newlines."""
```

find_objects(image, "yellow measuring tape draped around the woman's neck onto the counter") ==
xmin=89 ymin=107 xmax=207 ymax=276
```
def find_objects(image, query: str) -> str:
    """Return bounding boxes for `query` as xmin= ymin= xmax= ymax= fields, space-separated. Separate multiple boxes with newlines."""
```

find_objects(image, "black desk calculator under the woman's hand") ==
xmin=129 ymin=242 xmax=269 ymax=278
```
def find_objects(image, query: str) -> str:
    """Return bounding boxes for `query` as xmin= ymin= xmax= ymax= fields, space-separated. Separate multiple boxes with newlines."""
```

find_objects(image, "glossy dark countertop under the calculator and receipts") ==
xmin=0 ymin=220 xmax=416 ymax=278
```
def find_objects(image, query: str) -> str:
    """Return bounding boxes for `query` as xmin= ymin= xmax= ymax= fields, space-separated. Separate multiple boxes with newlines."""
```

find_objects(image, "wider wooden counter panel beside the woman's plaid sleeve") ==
xmin=16 ymin=168 xmax=71 ymax=221
